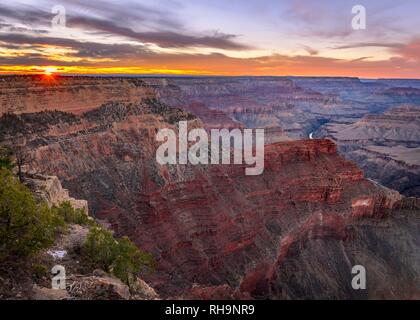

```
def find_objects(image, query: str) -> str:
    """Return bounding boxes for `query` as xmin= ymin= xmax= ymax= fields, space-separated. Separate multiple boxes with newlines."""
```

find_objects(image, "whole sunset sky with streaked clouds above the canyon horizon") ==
xmin=0 ymin=0 xmax=420 ymax=78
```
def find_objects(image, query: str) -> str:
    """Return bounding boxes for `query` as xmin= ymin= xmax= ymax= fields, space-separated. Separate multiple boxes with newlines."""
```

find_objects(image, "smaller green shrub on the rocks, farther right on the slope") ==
xmin=84 ymin=227 xmax=153 ymax=284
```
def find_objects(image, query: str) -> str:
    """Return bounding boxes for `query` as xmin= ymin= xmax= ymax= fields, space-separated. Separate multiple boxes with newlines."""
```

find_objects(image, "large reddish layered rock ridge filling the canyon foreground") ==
xmin=3 ymin=100 xmax=420 ymax=298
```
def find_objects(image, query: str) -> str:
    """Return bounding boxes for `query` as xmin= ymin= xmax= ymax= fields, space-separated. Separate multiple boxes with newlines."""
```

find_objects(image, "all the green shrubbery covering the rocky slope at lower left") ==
xmin=0 ymin=149 xmax=153 ymax=292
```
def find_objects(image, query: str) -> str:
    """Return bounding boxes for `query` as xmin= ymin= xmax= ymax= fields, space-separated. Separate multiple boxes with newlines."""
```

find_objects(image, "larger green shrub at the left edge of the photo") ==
xmin=0 ymin=169 xmax=63 ymax=259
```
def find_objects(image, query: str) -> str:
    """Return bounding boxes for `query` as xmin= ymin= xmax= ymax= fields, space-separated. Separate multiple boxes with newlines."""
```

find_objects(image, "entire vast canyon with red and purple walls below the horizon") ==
xmin=0 ymin=76 xmax=420 ymax=299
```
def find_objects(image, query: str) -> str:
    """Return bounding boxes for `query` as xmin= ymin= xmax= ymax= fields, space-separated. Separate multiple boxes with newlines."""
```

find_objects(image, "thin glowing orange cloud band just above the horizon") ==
xmin=0 ymin=50 xmax=420 ymax=78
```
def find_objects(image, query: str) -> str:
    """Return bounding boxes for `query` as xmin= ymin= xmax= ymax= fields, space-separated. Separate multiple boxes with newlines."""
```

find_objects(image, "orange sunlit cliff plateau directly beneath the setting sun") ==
xmin=0 ymin=75 xmax=153 ymax=115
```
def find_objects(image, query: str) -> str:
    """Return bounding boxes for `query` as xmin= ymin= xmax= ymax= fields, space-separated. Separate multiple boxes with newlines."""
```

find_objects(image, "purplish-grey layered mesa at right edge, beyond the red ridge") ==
xmin=316 ymin=105 xmax=420 ymax=196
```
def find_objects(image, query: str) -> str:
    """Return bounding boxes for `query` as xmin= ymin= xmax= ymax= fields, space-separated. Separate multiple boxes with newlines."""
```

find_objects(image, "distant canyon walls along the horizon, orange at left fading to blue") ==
xmin=0 ymin=76 xmax=420 ymax=141
